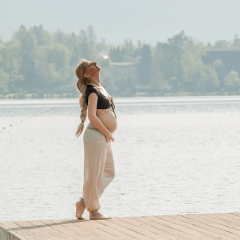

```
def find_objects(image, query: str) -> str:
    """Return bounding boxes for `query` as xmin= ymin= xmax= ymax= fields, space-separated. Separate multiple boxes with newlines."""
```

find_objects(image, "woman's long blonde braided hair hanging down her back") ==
xmin=75 ymin=59 xmax=90 ymax=137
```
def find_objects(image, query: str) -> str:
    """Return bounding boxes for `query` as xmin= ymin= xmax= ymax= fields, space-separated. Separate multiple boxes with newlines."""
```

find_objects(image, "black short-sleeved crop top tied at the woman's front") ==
xmin=85 ymin=84 xmax=114 ymax=109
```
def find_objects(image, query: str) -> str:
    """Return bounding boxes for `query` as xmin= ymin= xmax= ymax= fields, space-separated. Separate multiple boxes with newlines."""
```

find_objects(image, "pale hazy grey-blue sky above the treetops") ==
xmin=0 ymin=0 xmax=240 ymax=44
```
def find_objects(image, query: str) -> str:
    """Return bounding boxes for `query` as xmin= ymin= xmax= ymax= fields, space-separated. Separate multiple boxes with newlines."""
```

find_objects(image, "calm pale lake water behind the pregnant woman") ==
xmin=0 ymin=96 xmax=240 ymax=221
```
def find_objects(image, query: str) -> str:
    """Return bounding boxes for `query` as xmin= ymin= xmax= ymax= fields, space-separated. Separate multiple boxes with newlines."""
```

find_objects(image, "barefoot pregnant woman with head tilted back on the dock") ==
xmin=76 ymin=60 xmax=117 ymax=220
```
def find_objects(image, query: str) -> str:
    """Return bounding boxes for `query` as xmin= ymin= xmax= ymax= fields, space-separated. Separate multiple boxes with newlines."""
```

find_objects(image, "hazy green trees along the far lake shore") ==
xmin=0 ymin=25 xmax=240 ymax=96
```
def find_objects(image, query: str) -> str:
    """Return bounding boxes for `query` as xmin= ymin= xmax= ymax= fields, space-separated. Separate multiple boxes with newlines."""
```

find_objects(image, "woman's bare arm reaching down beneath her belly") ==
xmin=88 ymin=92 xmax=112 ymax=136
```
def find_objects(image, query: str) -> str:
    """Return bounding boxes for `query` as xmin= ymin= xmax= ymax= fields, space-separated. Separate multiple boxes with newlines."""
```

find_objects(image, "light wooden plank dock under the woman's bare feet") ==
xmin=0 ymin=213 xmax=240 ymax=240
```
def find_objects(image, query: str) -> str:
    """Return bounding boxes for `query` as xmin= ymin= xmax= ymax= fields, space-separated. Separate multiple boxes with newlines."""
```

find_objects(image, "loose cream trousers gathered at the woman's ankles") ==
xmin=83 ymin=122 xmax=115 ymax=211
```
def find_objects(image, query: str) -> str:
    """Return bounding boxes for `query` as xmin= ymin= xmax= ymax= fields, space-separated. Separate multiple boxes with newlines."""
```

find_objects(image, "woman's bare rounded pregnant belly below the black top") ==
xmin=96 ymin=108 xmax=117 ymax=133
